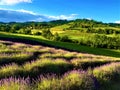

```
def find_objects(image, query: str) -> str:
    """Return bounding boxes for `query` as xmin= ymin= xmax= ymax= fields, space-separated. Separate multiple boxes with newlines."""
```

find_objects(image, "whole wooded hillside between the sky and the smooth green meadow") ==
xmin=0 ymin=19 xmax=120 ymax=49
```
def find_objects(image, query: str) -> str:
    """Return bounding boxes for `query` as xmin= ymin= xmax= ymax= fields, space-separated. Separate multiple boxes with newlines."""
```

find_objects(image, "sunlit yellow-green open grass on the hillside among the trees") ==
xmin=51 ymin=23 xmax=120 ymax=40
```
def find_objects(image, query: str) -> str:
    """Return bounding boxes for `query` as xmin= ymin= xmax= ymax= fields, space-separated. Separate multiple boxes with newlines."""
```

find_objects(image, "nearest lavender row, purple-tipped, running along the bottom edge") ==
xmin=0 ymin=63 xmax=120 ymax=90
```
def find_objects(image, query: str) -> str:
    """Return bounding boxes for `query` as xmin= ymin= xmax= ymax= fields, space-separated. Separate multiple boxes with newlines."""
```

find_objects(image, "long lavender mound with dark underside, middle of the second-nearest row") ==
xmin=23 ymin=59 xmax=73 ymax=77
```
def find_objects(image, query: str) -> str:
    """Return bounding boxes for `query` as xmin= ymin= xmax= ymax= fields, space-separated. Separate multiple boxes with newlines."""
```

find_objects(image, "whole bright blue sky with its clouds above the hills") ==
xmin=0 ymin=0 xmax=120 ymax=23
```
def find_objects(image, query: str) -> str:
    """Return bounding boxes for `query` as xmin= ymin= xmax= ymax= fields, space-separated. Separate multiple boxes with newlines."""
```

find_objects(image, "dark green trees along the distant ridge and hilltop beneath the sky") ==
xmin=0 ymin=19 xmax=120 ymax=34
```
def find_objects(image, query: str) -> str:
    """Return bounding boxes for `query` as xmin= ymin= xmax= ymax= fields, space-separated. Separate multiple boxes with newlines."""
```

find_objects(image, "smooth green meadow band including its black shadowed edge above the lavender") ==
xmin=0 ymin=32 xmax=120 ymax=58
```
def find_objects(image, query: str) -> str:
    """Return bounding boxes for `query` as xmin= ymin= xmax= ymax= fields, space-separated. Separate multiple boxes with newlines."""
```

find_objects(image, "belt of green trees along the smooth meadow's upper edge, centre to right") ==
xmin=42 ymin=29 xmax=120 ymax=49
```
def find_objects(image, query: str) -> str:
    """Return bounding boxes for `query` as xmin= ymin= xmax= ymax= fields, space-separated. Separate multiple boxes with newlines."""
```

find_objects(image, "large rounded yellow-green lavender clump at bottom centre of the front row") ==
xmin=36 ymin=71 xmax=94 ymax=90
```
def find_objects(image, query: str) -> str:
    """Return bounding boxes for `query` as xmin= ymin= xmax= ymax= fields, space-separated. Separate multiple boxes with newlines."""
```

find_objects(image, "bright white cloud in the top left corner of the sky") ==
xmin=0 ymin=0 xmax=32 ymax=5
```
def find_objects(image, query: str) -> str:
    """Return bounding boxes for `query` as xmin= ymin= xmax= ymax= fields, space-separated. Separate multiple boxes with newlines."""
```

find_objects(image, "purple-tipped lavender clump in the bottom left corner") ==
xmin=0 ymin=77 xmax=31 ymax=90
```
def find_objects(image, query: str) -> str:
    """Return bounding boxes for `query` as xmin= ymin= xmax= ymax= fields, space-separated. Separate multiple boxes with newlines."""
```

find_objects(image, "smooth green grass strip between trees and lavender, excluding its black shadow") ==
xmin=0 ymin=32 xmax=120 ymax=58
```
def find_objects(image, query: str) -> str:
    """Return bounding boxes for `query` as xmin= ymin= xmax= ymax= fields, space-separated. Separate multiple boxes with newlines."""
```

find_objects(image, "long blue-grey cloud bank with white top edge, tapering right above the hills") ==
xmin=0 ymin=9 xmax=77 ymax=22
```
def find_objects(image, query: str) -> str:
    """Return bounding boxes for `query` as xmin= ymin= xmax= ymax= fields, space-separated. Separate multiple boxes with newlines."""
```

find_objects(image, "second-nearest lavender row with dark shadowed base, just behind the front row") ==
xmin=0 ymin=59 xmax=118 ymax=79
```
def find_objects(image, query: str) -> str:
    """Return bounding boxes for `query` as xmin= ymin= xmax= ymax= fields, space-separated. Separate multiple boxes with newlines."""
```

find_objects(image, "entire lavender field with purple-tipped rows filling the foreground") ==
xmin=0 ymin=40 xmax=120 ymax=90
